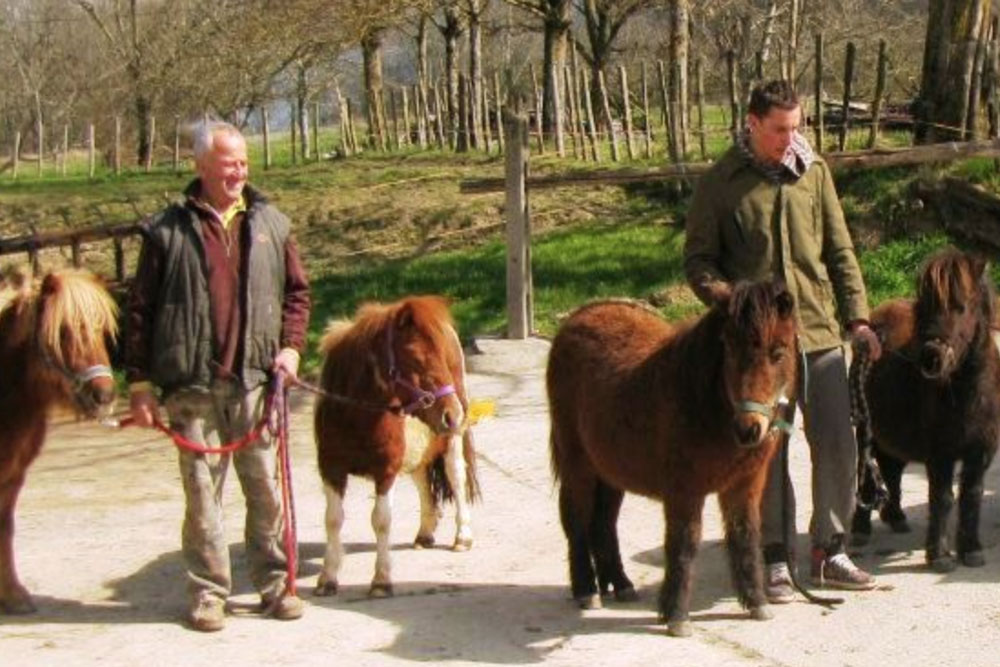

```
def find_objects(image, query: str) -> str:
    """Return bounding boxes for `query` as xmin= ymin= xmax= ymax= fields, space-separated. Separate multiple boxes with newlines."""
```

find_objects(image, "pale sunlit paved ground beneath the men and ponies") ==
xmin=0 ymin=340 xmax=1000 ymax=667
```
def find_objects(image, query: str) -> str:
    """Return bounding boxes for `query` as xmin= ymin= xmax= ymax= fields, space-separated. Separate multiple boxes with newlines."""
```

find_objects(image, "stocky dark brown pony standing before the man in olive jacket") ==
xmin=547 ymin=283 xmax=797 ymax=636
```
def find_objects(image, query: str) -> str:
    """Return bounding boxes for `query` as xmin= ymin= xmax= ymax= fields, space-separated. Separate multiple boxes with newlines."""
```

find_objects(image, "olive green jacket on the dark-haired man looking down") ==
xmin=684 ymin=147 xmax=868 ymax=352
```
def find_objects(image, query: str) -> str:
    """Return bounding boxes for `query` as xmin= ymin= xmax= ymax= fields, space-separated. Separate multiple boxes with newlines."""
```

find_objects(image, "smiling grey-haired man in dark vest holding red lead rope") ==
xmin=125 ymin=123 xmax=310 ymax=631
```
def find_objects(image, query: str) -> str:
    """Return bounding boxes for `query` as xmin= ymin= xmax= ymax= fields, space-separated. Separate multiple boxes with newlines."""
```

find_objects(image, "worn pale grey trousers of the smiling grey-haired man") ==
xmin=166 ymin=383 xmax=287 ymax=603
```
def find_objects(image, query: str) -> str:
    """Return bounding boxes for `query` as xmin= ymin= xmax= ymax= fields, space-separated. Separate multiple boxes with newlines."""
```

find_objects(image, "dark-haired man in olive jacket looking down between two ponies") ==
xmin=684 ymin=81 xmax=881 ymax=603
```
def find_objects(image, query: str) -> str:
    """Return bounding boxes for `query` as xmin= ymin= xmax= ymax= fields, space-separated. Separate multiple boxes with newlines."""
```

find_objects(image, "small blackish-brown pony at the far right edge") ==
xmin=852 ymin=248 xmax=1000 ymax=572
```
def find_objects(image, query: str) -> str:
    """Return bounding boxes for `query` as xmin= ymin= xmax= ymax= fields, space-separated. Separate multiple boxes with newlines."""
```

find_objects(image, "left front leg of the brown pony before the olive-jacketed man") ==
xmin=660 ymin=493 xmax=705 ymax=637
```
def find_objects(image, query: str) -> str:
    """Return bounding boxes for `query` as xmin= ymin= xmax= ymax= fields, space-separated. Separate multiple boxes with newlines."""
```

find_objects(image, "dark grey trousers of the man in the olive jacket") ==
xmin=761 ymin=347 xmax=858 ymax=550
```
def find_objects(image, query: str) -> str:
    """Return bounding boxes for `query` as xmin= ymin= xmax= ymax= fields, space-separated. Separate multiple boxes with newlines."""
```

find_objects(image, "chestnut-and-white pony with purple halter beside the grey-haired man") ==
xmin=315 ymin=296 xmax=479 ymax=597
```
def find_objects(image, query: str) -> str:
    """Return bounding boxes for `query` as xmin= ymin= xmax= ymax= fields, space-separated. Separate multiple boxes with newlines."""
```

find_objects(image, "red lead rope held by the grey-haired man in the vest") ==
xmin=118 ymin=373 xmax=299 ymax=613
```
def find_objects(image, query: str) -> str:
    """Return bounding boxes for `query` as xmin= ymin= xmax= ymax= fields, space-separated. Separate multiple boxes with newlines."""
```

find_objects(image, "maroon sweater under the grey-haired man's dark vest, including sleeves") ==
xmin=125 ymin=184 xmax=311 ymax=382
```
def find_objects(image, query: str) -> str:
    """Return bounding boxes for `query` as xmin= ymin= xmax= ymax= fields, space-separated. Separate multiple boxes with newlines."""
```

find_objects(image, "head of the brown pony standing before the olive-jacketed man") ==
xmin=716 ymin=281 xmax=798 ymax=447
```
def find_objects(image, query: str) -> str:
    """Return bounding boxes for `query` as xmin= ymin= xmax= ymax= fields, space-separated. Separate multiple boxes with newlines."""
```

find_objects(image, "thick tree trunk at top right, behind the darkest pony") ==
xmin=915 ymin=0 xmax=990 ymax=143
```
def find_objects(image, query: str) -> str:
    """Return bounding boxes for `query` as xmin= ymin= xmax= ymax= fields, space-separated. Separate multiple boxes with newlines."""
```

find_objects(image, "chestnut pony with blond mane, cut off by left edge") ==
xmin=0 ymin=270 xmax=117 ymax=614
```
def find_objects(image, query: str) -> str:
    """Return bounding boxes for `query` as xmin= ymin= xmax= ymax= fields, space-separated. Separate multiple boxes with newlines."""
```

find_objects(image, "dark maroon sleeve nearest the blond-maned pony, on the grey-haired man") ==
xmin=124 ymin=235 xmax=163 ymax=383
